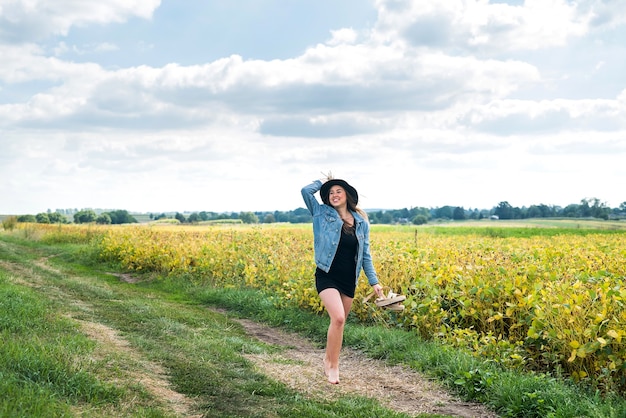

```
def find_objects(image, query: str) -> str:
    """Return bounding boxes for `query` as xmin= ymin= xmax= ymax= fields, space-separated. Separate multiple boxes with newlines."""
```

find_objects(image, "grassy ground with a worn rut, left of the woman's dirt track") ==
xmin=0 ymin=235 xmax=446 ymax=417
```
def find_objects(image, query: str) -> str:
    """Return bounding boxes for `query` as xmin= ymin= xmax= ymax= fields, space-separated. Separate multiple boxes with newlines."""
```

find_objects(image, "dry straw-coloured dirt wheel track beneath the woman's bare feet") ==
xmin=225 ymin=316 xmax=498 ymax=418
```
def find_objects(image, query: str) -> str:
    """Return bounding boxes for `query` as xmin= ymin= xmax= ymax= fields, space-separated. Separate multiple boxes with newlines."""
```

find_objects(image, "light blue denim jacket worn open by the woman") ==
xmin=302 ymin=180 xmax=378 ymax=286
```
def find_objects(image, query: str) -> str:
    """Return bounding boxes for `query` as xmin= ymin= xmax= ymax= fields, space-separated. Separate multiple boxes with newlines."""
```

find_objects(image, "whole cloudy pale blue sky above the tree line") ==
xmin=0 ymin=0 xmax=626 ymax=214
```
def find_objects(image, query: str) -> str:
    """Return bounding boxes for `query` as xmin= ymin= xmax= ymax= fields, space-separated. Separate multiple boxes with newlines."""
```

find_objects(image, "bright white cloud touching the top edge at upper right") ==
xmin=377 ymin=0 xmax=590 ymax=52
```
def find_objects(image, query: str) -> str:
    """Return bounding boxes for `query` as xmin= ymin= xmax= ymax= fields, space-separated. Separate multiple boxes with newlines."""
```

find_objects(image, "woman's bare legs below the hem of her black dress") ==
xmin=320 ymin=289 xmax=352 ymax=383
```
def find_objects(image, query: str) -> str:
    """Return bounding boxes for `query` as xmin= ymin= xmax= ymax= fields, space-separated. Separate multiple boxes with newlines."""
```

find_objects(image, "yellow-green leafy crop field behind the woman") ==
xmin=17 ymin=225 xmax=626 ymax=392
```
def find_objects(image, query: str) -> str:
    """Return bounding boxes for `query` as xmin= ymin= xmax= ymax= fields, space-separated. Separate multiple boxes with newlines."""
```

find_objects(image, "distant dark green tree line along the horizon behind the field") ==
xmin=9 ymin=198 xmax=626 ymax=225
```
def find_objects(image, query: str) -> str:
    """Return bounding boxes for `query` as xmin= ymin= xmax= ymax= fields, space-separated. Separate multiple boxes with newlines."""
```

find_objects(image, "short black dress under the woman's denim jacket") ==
xmin=315 ymin=226 xmax=359 ymax=298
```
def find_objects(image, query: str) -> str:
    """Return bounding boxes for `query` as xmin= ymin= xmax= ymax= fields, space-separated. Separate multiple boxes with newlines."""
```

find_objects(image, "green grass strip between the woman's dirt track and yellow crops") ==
xmin=188 ymin=282 xmax=626 ymax=418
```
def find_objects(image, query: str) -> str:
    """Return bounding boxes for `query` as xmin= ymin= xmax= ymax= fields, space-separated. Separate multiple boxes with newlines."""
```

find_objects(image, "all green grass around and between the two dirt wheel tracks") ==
xmin=0 ymin=230 xmax=626 ymax=418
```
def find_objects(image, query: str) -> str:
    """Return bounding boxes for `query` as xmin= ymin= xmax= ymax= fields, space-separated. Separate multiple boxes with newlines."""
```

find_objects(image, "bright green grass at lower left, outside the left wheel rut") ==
xmin=0 ymin=271 xmax=123 ymax=416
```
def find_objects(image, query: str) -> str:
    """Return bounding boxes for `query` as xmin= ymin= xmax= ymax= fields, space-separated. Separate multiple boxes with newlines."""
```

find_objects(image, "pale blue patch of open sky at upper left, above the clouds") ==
xmin=50 ymin=0 xmax=376 ymax=68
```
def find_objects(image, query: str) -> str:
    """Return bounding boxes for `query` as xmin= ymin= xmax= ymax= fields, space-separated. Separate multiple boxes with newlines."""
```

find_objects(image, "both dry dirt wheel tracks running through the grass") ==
xmin=0 ymin=251 xmax=498 ymax=418
